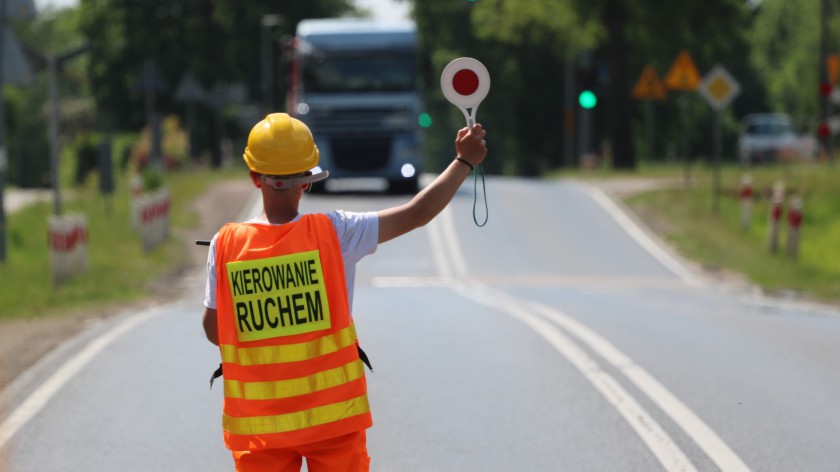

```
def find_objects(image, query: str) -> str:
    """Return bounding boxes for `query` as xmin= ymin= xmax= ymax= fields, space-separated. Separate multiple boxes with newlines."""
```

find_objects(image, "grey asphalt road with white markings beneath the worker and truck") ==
xmin=0 ymin=178 xmax=840 ymax=472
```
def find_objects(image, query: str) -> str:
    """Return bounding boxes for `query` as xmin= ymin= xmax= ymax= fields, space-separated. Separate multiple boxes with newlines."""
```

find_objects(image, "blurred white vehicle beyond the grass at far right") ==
xmin=738 ymin=113 xmax=801 ymax=166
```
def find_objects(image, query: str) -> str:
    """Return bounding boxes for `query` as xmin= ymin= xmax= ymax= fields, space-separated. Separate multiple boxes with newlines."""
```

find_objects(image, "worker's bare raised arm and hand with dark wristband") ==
xmin=378 ymin=124 xmax=487 ymax=243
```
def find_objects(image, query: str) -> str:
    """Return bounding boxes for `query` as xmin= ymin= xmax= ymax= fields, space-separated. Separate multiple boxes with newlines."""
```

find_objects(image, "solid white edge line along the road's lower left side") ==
xmin=0 ymin=310 xmax=162 ymax=448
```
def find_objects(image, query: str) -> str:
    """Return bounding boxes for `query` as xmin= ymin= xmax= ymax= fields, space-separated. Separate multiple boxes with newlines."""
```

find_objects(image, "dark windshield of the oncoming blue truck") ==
xmin=303 ymin=52 xmax=416 ymax=93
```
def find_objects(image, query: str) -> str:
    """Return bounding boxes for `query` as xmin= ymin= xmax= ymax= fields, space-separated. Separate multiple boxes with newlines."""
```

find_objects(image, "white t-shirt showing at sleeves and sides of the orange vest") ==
xmin=204 ymin=210 xmax=379 ymax=313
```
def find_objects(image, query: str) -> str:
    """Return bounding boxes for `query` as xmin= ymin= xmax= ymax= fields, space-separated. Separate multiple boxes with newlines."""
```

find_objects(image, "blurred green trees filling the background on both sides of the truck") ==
xmin=4 ymin=0 xmax=840 ymax=185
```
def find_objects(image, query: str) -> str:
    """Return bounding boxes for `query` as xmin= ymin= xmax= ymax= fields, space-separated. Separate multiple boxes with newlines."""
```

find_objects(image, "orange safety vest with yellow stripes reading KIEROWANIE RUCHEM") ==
xmin=216 ymin=214 xmax=372 ymax=451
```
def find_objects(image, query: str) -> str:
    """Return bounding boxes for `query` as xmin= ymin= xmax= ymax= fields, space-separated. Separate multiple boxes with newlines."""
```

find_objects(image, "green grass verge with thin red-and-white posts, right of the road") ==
xmin=627 ymin=164 xmax=840 ymax=303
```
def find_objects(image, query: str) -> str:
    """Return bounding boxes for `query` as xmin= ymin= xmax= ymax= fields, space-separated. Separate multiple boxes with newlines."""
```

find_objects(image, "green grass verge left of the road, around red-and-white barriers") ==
xmin=0 ymin=165 xmax=242 ymax=320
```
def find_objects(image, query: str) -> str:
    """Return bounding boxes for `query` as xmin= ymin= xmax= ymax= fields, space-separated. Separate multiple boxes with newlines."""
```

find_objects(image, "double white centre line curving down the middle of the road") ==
xmin=429 ymin=204 xmax=750 ymax=472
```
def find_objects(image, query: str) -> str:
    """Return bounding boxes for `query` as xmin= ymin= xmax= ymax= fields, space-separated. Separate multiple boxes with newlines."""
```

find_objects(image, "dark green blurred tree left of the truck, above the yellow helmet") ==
xmin=79 ymin=0 xmax=351 ymax=159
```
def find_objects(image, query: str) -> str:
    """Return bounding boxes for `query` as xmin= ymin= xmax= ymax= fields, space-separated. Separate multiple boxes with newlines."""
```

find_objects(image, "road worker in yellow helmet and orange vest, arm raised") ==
xmin=203 ymin=113 xmax=487 ymax=472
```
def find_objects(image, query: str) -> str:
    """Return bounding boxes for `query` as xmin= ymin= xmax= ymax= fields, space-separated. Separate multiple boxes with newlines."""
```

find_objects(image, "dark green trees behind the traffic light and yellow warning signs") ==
xmin=414 ymin=0 xmax=763 ymax=174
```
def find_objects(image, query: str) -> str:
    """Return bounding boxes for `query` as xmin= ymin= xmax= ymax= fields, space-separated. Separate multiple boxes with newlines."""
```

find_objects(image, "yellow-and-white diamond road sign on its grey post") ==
xmin=697 ymin=64 xmax=741 ymax=213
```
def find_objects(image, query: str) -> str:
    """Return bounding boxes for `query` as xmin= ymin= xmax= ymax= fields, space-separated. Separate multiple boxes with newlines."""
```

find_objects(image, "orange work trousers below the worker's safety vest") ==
xmin=233 ymin=430 xmax=370 ymax=472
